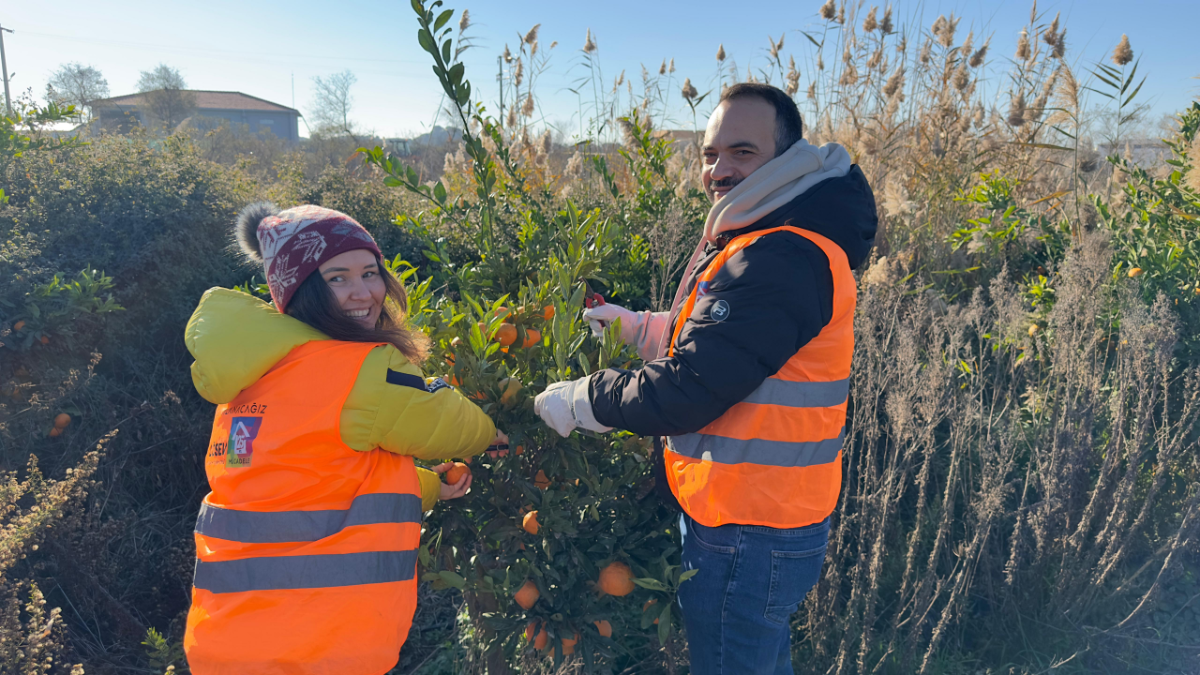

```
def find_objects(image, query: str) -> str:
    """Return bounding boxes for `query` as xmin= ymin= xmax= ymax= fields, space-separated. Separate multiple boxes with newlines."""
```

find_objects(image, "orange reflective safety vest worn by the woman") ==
xmin=184 ymin=340 xmax=421 ymax=675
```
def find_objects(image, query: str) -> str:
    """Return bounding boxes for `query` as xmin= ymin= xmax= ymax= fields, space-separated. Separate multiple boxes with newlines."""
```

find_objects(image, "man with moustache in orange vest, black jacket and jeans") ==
xmin=535 ymin=83 xmax=877 ymax=675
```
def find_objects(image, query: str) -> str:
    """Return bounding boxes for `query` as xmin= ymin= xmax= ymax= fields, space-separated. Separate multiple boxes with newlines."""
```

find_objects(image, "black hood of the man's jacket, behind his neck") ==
xmin=724 ymin=165 xmax=880 ymax=269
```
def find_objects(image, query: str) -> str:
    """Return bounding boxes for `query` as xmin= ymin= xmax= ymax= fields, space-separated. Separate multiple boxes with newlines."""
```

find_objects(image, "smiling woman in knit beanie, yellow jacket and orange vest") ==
xmin=184 ymin=203 xmax=508 ymax=675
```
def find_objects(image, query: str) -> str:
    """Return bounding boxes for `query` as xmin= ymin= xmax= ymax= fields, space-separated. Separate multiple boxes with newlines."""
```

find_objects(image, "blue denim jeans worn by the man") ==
xmin=678 ymin=514 xmax=829 ymax=675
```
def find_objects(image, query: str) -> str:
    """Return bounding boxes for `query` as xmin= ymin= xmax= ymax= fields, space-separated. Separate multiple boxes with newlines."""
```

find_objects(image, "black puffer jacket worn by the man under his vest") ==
xmin=588 ymin=166 xmax=878 ymax=436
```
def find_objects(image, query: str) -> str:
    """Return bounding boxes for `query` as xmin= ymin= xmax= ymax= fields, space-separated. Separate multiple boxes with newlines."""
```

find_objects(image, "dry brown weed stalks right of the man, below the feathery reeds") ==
xmin=804 ymin=234 xmax=1200 ymax=673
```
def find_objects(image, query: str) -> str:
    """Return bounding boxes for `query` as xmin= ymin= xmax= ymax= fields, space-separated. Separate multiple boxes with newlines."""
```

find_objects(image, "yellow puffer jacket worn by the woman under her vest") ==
xmin=185 ymin=288 xmax=496 ymax=510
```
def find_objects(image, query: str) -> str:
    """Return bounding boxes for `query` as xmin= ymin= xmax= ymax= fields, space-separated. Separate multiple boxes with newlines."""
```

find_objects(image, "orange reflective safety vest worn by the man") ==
xmin=664 ymin=226 xmax=857 ymax=528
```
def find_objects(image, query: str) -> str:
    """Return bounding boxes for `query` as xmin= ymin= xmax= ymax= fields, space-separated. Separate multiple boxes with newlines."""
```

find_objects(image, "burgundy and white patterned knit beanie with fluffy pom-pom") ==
xmin=234 ymin=202 xmax=382 ymax=312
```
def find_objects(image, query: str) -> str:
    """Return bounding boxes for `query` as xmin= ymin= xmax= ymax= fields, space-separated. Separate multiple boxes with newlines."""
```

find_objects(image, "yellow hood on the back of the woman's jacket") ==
xmin=184 ymin=288 xmax=328 ymax=405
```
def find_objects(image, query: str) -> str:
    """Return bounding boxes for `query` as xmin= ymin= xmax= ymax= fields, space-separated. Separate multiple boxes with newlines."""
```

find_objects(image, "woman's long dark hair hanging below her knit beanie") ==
xmin=287 ymin=249 xmax=430 ymax=365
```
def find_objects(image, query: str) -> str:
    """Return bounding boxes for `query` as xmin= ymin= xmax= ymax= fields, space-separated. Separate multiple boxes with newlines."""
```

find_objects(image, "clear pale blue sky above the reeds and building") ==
xmin=0 ymin=0 xmax=1200 ymax=136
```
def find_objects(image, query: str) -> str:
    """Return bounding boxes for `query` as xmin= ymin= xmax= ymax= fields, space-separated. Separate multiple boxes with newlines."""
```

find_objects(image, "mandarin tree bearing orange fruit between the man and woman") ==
xmin=362 ymin=0 xmax=705 ymax=673
